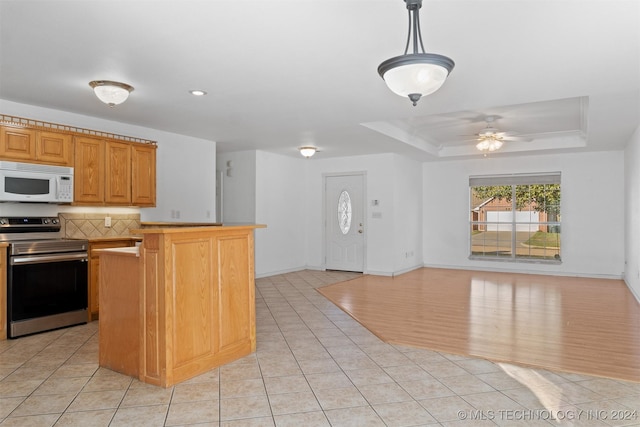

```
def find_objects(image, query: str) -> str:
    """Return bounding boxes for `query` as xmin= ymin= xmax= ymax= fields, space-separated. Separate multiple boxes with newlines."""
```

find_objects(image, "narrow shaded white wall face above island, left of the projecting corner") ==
xmin=216 ymin=151 xmax=256 ymax=224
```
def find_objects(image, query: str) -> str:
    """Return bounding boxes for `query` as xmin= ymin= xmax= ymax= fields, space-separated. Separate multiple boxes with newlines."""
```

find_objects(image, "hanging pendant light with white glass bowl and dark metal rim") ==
xmin=378 ymin=0 xmax=455 ymax=106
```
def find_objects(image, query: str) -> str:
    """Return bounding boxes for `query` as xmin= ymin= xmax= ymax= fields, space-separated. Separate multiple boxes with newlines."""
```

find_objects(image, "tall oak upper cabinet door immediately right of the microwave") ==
xmin=73 ymin=136 xmax=105 ymax=205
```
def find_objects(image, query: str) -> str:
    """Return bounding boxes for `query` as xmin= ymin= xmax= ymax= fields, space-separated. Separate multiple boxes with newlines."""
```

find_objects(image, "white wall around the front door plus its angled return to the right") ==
xmin=306 ymin=154 xmax=422 ymax=276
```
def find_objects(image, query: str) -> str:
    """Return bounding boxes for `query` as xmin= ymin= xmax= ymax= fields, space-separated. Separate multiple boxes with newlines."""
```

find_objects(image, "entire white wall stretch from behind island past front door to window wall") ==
xmin=217 ymin=151 xmax=422 ymax=277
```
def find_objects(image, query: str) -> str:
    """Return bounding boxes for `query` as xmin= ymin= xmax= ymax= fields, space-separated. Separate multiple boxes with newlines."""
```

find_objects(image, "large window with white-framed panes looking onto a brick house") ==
xmin=469 ymin=173 xmax=561 ymax=262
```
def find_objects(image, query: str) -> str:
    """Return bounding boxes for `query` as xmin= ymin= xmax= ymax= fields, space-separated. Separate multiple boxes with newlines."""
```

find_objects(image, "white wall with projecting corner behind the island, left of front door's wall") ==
xmin=217 ymin=151 xmax=306 ymax=277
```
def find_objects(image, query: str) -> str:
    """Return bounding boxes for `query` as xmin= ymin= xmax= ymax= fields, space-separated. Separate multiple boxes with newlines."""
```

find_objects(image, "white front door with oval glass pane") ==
xmin=325 ymin=174 xmax=365 ymax=272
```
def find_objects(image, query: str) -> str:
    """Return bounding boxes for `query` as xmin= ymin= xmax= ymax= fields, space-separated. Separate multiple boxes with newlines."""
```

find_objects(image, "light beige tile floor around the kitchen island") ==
xmin=0 ymin=271 xmax=640 ymax=427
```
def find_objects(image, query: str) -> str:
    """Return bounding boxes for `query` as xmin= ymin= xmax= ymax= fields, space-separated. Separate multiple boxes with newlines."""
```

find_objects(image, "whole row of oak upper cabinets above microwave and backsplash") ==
xmin=0 ymin=115 xmax=158 ymax=206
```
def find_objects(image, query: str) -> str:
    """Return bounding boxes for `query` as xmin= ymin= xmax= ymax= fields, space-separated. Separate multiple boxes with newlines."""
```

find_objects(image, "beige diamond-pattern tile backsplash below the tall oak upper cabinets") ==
xmin=59 ymin=212 xmax=140 ymax=239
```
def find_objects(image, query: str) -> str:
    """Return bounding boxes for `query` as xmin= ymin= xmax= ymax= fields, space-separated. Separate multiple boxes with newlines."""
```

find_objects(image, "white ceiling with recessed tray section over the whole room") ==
xmin=0 ymin=0 xmax=640 ymax=161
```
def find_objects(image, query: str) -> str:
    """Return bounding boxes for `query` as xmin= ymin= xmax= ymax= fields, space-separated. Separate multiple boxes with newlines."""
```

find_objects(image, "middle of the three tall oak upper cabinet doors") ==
xmin=104 ymin=141 xmax=132 ymax=205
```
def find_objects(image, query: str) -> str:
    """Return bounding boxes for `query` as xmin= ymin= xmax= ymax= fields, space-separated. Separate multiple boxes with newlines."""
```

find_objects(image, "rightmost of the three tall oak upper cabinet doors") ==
xmin=131 ymin=144 xmax=157 ymax=206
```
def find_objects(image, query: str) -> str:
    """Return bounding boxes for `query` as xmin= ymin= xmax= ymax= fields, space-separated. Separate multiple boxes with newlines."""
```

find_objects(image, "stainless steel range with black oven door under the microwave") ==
xmin=0 ymin=217 xmax=89 ymax=338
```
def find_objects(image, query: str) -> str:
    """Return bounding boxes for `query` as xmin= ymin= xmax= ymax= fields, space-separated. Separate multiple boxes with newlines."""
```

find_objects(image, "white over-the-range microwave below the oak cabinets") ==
xmin=0 ymin=161 xmax=73 ymax=203
